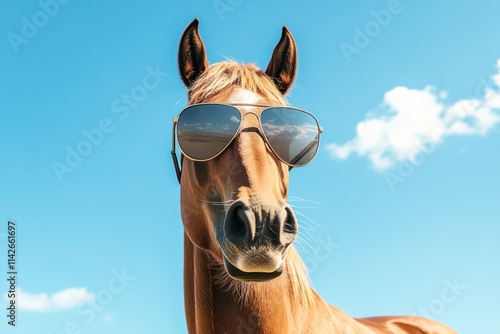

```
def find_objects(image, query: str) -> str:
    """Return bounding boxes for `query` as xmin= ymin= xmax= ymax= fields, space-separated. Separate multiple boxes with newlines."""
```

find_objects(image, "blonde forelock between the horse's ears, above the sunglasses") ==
xmin=188 ymin=60 xmax=286 ymax=105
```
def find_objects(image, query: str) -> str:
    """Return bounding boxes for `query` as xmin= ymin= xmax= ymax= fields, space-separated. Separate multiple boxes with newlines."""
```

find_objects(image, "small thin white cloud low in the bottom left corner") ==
xmin=6 ymin=288 xmax=94 ymax=312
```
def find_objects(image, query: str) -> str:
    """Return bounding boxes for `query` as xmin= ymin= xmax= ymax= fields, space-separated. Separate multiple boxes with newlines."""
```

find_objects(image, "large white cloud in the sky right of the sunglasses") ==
xmin=327 ymin=59 xmax=500 ymax=171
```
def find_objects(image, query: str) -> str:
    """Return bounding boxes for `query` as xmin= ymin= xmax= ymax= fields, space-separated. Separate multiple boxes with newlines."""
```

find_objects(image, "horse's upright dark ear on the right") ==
xmin=266 ymin=26 xmax=297 ymax=95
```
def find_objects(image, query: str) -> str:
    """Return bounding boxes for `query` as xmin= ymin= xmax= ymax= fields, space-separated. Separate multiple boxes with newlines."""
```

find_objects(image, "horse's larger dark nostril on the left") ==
xmin=224 ymin=202 xmax=255 ymax=246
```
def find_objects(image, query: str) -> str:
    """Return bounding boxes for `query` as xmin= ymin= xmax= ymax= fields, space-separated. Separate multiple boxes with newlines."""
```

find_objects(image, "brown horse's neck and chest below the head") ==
xmin=184 ymin=235 xmax=366 ymax=334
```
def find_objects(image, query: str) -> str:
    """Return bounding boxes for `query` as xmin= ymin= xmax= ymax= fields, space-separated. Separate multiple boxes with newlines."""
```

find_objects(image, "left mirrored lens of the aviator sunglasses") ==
xmin=177 ymin=104 xmax=241 ymax=160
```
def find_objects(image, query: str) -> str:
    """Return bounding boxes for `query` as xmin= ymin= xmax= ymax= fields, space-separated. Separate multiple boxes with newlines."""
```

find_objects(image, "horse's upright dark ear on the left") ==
xmin=178 ymin=19 xmax=208 ymax=87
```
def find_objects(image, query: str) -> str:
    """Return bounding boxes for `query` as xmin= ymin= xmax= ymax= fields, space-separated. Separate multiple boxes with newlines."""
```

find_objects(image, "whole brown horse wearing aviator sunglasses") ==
xmin=172 ymin=19 xmax=455 ymax=334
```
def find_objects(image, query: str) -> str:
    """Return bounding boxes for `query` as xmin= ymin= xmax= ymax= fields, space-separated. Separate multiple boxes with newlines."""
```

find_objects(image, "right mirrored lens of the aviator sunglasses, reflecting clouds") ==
xmin=260 ymin=107 xmax=319 ymax=166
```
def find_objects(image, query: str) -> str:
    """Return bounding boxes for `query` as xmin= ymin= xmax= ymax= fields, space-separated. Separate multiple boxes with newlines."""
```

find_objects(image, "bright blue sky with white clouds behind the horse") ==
xmin=0 ymin=0 xmax=500 ymax=334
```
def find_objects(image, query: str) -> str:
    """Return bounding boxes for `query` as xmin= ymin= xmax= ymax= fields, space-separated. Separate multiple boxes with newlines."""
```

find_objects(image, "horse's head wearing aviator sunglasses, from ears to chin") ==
xmin=173 ymin=19 xmax=321 ymax=281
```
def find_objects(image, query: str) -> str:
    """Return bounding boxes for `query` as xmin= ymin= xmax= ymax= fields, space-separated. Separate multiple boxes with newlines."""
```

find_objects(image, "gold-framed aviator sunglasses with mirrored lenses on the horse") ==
xmin=172 ymin=103 xmax=323 ymax=182
